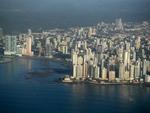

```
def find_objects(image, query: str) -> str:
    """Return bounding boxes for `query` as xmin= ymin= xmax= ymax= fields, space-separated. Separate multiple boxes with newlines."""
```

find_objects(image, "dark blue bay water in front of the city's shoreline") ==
xmin=0 ymin=58 xmax=150 ymax=113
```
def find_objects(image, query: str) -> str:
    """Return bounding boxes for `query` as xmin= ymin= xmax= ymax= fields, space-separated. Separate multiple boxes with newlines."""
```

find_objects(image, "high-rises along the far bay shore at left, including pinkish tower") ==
xmin=3 ymin=29 xmax=70 ymax=58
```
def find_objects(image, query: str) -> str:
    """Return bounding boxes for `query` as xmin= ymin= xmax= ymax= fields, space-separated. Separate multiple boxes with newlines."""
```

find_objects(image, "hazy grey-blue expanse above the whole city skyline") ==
xmin=0 ymin=0 xmax=150 ymax=33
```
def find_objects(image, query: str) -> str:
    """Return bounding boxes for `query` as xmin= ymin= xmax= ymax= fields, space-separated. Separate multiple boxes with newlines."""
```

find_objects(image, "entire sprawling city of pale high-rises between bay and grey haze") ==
xmin=0 ymin=19 xmax=150 ymax=81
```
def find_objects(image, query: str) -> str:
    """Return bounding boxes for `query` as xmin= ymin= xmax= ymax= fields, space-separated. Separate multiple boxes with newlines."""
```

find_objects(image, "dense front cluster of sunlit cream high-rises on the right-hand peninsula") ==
xmin=72 ymin=38 xmax=150 ymax=82
